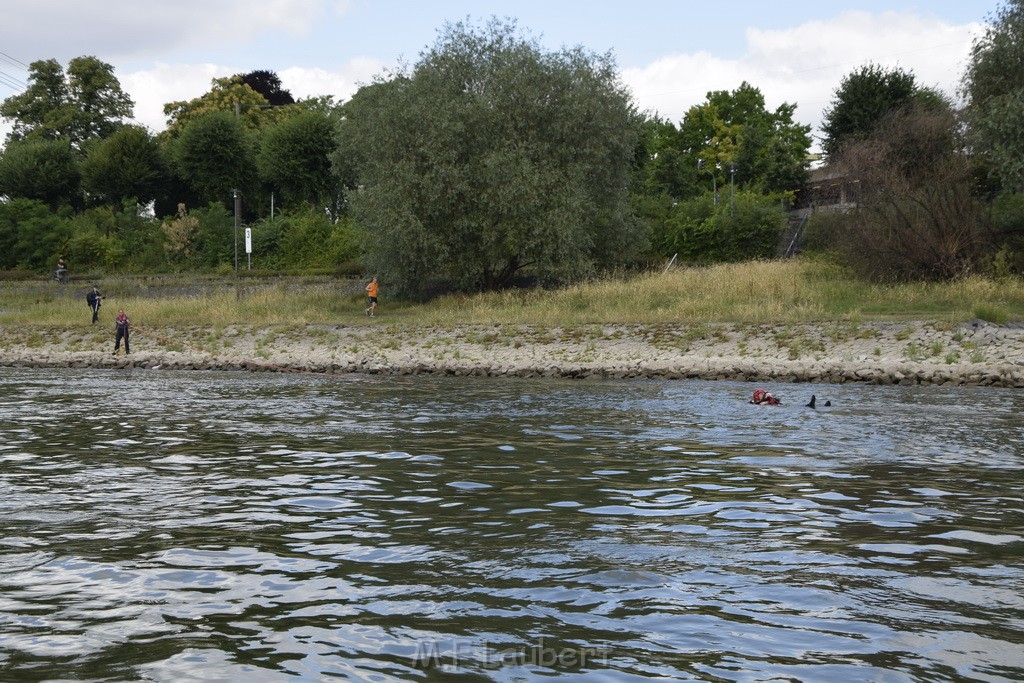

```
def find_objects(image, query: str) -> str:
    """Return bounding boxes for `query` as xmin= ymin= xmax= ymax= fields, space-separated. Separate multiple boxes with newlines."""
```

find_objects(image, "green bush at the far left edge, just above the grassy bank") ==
xmin=0 ymin=199 xmax=75 ymax=270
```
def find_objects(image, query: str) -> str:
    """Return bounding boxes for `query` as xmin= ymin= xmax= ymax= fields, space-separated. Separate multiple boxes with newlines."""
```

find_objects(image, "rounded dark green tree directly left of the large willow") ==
xmin=257 ymin=111 xmax=340 ymax=215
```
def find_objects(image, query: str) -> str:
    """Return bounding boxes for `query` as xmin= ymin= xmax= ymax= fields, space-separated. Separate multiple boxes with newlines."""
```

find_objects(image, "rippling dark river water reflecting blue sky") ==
xmin=0 ymin=369 xmax=1024 ymax=683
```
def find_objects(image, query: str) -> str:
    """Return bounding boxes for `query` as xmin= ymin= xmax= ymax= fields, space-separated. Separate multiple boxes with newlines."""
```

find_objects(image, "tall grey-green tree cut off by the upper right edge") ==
xmin=963 ymin=0 xmax=1024 ymax=193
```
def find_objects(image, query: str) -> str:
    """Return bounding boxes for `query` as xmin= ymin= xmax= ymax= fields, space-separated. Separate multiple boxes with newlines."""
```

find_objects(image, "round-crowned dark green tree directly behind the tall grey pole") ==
xmin=170 ymin=112 xmax=256 ymax=205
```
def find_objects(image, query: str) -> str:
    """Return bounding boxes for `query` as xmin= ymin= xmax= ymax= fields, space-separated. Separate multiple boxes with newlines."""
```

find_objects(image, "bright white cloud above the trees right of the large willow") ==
xmin=623 ymin=11 xmax=980 ymax=142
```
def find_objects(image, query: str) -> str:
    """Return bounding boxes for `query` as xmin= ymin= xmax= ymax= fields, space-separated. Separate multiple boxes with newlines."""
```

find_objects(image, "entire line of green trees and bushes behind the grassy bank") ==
xmin=0 ymin=5 xmax=1024 ymax=295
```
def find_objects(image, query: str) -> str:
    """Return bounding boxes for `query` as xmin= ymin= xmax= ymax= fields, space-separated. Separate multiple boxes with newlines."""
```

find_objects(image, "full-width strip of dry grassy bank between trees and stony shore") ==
xmin=0 ymin=260 xmax=1024 ymax=328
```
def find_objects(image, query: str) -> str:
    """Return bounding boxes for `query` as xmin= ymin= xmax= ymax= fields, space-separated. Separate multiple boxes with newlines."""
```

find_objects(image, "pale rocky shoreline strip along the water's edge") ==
xmin=0 ymin=321 xmax=1024 ymax=388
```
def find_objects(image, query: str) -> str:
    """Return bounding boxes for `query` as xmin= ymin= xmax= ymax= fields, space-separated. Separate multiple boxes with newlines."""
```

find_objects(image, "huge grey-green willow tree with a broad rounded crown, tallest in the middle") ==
xmin=335 ymin=19 xmax=642 ymax=292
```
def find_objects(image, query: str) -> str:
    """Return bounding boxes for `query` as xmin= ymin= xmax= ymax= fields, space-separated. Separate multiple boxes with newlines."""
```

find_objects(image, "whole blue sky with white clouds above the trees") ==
xmin=0 ymin=0 xmax=998 ymax=143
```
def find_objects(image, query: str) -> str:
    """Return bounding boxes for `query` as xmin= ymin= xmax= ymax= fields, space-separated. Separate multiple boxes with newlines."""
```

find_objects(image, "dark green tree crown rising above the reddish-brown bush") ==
xmin=821 ymin=63 xmax=918 ymax=158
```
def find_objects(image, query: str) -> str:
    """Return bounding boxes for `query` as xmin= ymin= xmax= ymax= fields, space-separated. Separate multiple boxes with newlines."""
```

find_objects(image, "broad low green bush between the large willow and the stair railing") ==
xmin=663 ymin=191 xmax=785 ymax=263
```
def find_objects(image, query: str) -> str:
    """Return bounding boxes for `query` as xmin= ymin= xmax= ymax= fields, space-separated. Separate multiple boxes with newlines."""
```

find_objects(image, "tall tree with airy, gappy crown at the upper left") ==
xmin=0 ymin=56 xmax=134 ymax=148
